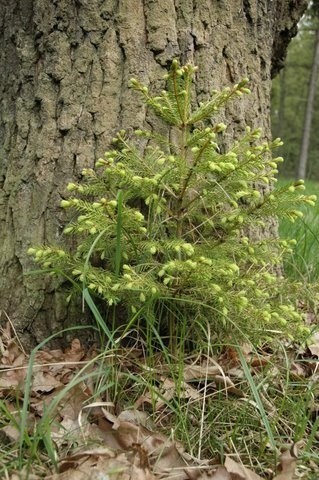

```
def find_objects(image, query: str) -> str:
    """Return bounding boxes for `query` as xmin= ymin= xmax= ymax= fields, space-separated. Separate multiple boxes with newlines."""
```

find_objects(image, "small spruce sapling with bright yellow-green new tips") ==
xmin=29 ymin=61 xmax=315 ymax=342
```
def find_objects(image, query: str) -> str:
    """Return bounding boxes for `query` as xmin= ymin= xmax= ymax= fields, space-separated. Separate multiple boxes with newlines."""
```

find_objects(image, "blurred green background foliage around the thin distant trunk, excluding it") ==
xmin=271 ymin=9 xmax=319 ymax=180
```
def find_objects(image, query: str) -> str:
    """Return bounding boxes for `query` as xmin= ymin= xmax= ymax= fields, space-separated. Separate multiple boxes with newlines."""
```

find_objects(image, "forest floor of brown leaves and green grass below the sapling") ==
xmin=0 ymin=317 xmax=319 ymax=480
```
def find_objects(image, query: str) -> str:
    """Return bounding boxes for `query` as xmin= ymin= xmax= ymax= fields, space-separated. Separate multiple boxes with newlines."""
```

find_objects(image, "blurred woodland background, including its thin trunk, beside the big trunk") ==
xmin=272 ymin=1 xmax=319 ymax=179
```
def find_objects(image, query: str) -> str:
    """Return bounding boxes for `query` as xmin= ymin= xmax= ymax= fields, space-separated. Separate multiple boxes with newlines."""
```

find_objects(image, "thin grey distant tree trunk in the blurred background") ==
xmin=297 ymin=27 xmax=319 ymax=179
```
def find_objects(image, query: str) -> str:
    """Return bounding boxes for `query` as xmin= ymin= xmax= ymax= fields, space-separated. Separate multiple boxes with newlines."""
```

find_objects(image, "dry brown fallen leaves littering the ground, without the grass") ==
xmin=0 ymin=323 xmax=317 ymax=480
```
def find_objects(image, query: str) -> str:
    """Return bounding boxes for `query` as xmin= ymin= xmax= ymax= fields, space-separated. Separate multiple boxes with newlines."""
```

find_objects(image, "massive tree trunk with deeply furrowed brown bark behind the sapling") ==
xmin=0 ymin=0 xmax=307 ymax=343
